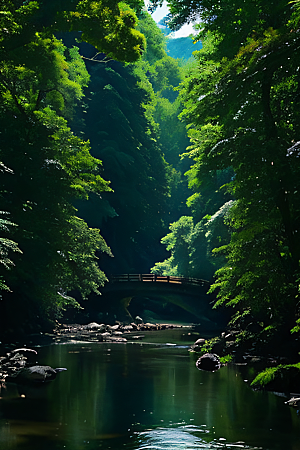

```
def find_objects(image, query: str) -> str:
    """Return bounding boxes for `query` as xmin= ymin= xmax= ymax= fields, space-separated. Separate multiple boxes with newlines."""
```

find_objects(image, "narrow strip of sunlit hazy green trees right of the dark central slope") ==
xmin=135 ymin=13 xmax=189 ymax=224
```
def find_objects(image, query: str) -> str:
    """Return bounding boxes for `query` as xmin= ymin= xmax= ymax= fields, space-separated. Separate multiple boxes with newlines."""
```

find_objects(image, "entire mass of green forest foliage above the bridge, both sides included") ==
xmin=5 ymin=0 xmax=300 ymax=350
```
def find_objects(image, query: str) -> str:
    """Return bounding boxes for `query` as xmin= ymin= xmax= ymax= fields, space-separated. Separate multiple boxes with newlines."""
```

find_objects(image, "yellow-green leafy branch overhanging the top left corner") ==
xmin=1 ymin=0 xmax=145 ymax=61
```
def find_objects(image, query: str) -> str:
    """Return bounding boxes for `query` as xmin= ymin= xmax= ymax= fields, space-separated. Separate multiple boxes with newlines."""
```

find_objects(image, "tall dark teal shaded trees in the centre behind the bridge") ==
xmin=73 ymin=55 xmax=168 ymax=273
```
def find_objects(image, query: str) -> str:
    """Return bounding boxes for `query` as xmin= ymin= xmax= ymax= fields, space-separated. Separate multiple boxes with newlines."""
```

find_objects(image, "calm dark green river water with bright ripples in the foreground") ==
xmin=0 ymin=329 xmax=300 ymax=450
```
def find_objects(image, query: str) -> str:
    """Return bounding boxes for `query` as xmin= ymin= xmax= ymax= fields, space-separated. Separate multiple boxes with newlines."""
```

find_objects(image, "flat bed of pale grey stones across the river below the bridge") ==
xmin=53 ymin=322 xmax=180 ymax=342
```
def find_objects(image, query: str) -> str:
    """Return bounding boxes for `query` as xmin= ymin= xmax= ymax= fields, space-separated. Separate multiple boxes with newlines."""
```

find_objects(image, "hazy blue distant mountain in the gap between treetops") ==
xmin=157 ymin=17 xmax=202 ymax=61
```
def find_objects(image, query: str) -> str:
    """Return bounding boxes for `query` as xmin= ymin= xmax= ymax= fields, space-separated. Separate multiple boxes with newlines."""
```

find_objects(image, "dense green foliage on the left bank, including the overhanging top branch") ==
xmin=0 ymin=0 xmax=145 ymax=332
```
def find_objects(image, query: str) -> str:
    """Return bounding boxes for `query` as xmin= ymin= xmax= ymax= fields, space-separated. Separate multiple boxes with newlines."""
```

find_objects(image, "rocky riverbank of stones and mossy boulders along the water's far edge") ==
xmin=0 ymin=322 xmax=300 ymax=408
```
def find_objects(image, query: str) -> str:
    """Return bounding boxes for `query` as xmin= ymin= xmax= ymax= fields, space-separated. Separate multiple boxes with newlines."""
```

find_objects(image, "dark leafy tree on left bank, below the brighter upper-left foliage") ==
xmin=0 ymin=108 xmax=112 ymax=326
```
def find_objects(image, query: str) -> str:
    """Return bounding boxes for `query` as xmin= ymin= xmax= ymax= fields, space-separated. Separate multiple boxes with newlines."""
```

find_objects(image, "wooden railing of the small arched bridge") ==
xmin=109 ymin=273 xmax=209 ymax=286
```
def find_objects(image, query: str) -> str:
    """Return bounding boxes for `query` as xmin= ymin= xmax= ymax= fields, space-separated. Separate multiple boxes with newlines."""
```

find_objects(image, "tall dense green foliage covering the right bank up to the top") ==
xmin=149 ymin=0 xmax=300 ymax=348
